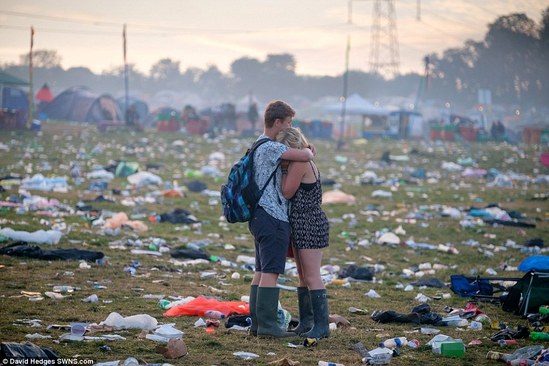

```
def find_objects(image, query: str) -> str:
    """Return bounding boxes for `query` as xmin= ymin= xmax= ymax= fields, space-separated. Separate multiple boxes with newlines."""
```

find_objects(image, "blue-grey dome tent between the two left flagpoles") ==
xmin=39 ymin=86 xmax=123 ymax=122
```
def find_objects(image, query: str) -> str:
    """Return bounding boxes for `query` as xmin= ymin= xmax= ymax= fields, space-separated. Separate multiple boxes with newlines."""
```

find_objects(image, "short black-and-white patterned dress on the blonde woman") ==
xmin=289 ymin=162 xmax=330 ymax=249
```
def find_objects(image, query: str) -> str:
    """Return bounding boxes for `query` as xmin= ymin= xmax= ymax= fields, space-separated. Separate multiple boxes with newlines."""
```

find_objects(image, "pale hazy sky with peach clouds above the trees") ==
xmin=0 ymin=0 xmax=549 ymax=75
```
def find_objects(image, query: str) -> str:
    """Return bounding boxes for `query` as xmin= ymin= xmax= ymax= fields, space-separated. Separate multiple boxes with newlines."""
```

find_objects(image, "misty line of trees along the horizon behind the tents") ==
xmin=0 ymin=7 xmax=549 ymax=116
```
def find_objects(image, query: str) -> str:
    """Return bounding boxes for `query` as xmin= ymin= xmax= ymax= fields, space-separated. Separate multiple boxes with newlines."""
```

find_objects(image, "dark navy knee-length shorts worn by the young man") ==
xmin=248 ymin=206 xmax=290 ymax=274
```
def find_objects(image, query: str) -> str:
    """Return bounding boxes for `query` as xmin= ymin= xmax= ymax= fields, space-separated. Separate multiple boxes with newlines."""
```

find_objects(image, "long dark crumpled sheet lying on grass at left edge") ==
xmin=0 ymin=242 xmax=104 ymax=262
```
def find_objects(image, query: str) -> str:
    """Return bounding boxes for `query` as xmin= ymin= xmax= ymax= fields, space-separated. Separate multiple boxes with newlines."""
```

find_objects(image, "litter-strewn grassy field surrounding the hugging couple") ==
xmin=0 ymin=123 xmax=549 ymax=365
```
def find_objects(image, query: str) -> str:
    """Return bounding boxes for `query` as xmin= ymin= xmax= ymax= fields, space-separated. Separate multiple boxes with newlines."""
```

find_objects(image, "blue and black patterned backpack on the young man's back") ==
xmin=221 ymin=138 xmax=280 ymax=223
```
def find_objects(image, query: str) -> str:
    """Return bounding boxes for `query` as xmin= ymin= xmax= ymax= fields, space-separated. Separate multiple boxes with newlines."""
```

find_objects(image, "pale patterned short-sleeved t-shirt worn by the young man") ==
xmin=254 ymin=135 xmax=288 ymax=222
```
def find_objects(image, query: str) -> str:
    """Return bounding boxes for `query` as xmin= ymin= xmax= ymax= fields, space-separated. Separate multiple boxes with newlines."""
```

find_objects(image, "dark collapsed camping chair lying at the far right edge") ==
xmin=502 ymin=270 xmax=549 ymax=316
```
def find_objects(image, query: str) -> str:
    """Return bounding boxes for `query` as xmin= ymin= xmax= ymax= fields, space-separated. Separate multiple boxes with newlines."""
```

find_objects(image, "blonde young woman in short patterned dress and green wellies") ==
xmin=276 ymin=127 xmax=330 ymax=338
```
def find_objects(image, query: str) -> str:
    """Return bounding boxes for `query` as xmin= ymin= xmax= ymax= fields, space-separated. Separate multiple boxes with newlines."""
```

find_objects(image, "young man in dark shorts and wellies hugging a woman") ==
xmin=248 ymin=101 xmax=314 ymax=338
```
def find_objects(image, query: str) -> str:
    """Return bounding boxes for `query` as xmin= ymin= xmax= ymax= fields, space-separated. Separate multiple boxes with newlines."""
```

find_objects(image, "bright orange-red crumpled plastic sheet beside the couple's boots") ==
xmin=163 ymin=296 xmax=250 ymax=317
